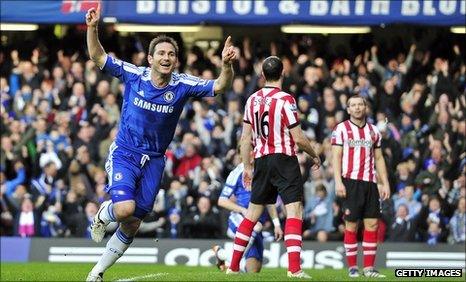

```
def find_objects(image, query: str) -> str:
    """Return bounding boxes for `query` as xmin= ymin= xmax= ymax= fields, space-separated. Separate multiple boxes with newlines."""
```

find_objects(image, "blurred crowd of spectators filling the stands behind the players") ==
xmin=0 ymin=29 xmax=466 ymax=244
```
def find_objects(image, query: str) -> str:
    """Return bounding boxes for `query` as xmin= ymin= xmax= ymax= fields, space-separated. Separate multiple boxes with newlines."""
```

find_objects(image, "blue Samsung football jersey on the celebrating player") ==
xmin=102 ymin=55 xmax=214 ymax=156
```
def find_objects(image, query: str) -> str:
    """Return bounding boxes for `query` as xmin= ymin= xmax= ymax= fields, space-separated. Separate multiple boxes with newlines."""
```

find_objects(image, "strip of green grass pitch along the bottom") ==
xmin=0 ymin=262 xmax=464 ymax=281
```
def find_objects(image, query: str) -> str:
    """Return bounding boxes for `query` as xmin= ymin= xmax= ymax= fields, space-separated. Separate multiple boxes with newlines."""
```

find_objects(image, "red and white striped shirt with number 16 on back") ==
xmin=243 ymin=87 xmax=299 ymax=158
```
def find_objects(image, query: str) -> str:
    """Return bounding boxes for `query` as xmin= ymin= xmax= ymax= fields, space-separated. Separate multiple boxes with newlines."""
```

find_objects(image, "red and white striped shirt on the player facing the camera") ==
xmin=332 ymin=120 xmax=382 ymax=183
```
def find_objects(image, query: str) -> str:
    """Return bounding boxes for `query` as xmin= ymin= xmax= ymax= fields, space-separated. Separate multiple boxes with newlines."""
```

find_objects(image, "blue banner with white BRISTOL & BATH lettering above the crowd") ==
xmin=1 ymin=0 xmax=466 ymax=26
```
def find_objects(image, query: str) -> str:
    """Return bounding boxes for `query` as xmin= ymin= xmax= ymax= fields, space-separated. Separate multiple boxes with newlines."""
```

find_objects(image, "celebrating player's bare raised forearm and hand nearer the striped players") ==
xmin=214 ymin=36 xmax=237 ymax=95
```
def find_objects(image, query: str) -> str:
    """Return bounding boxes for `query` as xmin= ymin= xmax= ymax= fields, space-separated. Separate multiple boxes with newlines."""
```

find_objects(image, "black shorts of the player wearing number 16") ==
xmin=251 ymin=154 xmax=304 ymax=205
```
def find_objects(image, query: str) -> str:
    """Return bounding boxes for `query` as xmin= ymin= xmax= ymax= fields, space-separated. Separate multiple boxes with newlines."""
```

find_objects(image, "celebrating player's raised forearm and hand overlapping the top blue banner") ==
xmin=86 ymin=3 xmax=106 ymax=68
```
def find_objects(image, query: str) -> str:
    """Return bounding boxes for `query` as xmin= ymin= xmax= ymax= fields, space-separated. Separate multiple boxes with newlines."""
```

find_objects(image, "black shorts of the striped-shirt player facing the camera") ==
xmin=342 ymin=178 xmax=380 ymax=222
